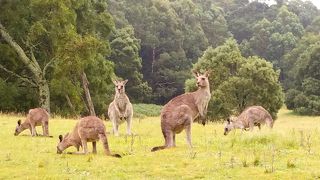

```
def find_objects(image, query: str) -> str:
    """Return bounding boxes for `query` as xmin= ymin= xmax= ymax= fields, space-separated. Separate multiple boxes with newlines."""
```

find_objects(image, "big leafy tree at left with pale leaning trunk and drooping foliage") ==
xmin=0 ymin=0 xmax=113 ymax=115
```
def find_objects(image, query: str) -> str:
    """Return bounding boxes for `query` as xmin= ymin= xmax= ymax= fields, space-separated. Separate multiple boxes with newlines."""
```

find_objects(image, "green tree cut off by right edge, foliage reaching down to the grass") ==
xmin=286 ymin=38 xmax=320 ymax=115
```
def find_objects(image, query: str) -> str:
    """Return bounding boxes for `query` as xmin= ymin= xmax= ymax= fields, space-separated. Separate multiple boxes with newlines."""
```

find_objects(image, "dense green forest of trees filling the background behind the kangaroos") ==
xmin=0 ymin=0 xmax=320 ymax=119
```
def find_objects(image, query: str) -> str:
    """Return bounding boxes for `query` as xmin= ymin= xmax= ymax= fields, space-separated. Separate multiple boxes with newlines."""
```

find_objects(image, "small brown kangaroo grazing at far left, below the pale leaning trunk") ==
xmin=14 ymin=108 xmax=49 ymax=136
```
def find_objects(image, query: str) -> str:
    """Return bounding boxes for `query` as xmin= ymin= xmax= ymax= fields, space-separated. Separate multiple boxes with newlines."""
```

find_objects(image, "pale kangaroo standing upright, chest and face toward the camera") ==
xmin=108 ymin=80 xmax=133 ymax=136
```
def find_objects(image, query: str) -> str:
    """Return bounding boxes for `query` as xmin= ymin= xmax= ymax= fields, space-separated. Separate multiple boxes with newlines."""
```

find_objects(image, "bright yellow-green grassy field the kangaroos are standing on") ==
xmin=0 ymin=107 xmax=320 ymax=179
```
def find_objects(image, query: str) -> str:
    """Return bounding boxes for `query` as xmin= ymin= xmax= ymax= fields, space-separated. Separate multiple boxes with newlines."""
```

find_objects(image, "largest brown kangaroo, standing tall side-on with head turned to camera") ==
xmin=151 ymin=72 xmax=211 ymax=152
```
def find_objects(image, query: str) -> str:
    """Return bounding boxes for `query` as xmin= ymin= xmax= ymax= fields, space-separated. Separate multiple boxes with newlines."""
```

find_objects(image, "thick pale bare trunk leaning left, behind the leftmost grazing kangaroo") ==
xmin=0 ymin=22 xmax=50 ymax=114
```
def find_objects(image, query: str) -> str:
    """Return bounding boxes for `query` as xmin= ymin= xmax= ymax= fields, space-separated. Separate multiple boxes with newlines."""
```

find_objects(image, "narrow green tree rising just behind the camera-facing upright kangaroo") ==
xmin=109 ymin=27 xmax=152 ymax=102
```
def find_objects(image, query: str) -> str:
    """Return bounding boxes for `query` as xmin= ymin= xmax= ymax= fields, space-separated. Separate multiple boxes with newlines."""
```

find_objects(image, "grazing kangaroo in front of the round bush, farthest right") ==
xmin=224 ymin=106 xmax=273 ymax=135
